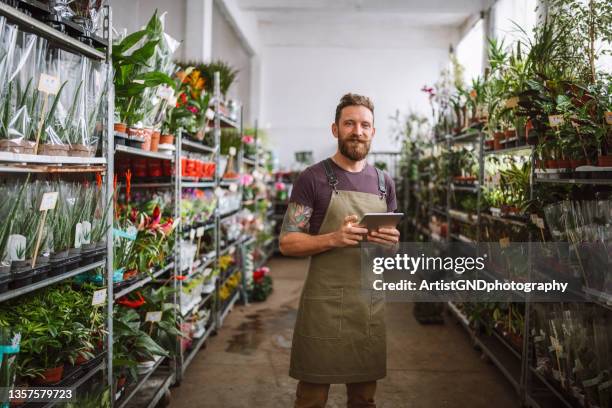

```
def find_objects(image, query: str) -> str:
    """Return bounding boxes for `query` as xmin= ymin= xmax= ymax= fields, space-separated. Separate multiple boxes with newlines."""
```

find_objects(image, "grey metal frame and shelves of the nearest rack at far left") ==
xmin=0 ymin=2 xmax=113 ymax=408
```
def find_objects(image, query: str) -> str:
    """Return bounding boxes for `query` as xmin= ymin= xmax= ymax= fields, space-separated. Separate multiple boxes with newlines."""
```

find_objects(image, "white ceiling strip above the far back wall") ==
xmin=239 ymin=0 xmax=494 ymax=28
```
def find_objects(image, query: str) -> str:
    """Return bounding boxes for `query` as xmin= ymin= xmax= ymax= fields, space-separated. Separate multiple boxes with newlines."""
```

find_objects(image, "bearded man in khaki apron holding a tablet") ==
xmin=280 ymin=94 xmax=399 ymax=408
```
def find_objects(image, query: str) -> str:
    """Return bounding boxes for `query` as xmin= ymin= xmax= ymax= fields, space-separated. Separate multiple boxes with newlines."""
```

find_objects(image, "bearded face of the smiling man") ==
xmin=332 ymin=105 xmax=375 ymax=161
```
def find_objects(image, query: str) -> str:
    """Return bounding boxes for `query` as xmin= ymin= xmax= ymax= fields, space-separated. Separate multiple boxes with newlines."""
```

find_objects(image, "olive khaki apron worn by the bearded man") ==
xmin=289 ymin=159 xmax=387 ymax=384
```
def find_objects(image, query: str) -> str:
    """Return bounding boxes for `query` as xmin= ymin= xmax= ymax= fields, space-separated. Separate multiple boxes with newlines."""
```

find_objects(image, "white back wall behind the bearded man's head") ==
xmin=260 ymin=25 xmax=455 ymax=168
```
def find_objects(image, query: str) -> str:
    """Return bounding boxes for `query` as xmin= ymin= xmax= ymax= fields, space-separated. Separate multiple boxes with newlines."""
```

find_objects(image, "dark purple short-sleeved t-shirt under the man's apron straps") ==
xmin=289 ymin=161 xmax=397 ymax=234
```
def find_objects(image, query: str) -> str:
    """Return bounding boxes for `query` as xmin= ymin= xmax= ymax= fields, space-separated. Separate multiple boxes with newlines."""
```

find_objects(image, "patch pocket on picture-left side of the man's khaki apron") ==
xmin=297 ymin=288 xmax=342 ymax=339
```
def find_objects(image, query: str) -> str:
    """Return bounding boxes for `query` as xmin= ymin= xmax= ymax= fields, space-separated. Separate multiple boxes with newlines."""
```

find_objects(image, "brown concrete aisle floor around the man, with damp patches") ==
xmin=170 ymin=258 xmax=519 ymax=408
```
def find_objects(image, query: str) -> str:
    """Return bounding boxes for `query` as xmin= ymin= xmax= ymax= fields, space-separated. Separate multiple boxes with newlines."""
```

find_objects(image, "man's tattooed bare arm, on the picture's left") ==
xmin=279 ymin=203 xmax=368 ymax=256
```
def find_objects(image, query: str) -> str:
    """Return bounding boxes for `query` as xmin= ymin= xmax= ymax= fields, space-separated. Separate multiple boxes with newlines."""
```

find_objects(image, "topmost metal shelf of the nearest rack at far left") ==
xmin=0 ymin=3 xmax=106 ymax=60
